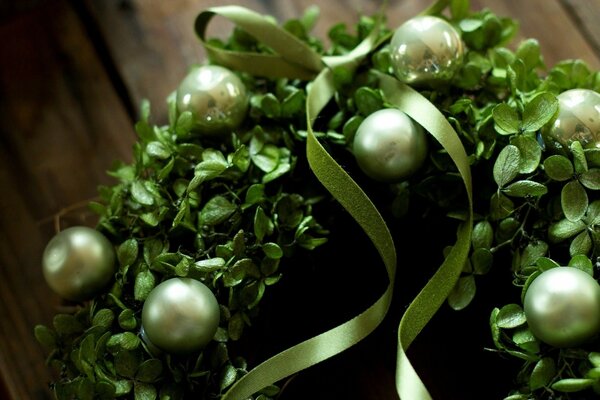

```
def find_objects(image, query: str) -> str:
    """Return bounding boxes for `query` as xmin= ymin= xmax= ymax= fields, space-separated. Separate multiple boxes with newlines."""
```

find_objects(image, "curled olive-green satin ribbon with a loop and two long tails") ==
xmin=195 ymin=6 xmax=473 ymax=400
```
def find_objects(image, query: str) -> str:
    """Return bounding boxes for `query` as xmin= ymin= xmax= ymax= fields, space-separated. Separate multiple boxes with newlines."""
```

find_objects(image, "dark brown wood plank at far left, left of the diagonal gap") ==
xmin=0 ymin=0 xmax=134 ymax=399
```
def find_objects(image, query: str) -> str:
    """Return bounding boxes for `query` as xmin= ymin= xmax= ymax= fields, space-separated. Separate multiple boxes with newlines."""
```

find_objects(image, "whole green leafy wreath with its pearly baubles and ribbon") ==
xmin=35 ymin=0 xmax=600 ymax=400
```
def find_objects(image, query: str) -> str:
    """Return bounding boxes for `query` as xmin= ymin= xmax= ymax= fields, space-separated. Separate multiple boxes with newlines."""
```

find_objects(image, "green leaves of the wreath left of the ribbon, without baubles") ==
xmin=35 ymin=9 xmax=328 ymax=400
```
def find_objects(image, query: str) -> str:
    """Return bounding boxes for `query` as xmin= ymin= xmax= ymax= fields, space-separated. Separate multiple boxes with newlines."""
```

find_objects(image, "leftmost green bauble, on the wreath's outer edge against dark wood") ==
xmin=42 ymin=226 xmax=116 ymax=301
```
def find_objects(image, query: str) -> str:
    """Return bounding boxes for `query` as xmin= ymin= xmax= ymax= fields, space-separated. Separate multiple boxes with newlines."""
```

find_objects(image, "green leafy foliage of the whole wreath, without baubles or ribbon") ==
xmin=35 ymin=0 xmax=600 ymax=400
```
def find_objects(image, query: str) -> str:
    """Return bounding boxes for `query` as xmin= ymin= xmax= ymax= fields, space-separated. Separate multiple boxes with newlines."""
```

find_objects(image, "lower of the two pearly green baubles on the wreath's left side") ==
xmin=142 ymin=278 xmax=220 ymax=354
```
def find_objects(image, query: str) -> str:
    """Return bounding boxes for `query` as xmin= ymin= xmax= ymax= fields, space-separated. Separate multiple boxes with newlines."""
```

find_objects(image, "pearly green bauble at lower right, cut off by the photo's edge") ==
xmin=524 ymin=267 xmax=600 ymax=347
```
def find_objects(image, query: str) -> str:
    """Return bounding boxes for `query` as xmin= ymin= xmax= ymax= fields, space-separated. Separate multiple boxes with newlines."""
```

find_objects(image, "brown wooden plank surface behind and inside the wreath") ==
xmin=0 ymin=0 xmax=600 ymax=400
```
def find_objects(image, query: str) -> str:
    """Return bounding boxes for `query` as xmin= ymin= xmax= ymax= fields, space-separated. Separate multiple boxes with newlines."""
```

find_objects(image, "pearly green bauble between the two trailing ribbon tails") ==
xmin=352 ymin=108 xmax=427 ymax=183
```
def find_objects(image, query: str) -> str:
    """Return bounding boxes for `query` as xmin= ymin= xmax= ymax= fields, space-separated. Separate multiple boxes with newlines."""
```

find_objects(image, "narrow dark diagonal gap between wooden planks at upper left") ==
xmin=68 ymin=0 xmax=139 ymax=124
